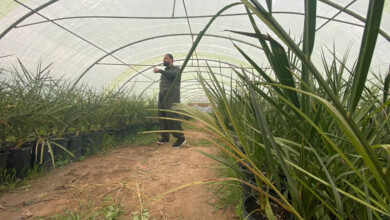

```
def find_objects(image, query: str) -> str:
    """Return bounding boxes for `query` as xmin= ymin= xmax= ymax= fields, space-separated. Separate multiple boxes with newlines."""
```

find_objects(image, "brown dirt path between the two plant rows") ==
xmin=0 ymin=124 xmax=238 ymax=220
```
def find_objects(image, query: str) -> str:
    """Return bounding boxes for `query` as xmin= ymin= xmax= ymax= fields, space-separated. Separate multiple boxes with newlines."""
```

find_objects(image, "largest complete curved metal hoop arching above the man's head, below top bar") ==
xmin=73 ymin=33 xmax=262 ymax=87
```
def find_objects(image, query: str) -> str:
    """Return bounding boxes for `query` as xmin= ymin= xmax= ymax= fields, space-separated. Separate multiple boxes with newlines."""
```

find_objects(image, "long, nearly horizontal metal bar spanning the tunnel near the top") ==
xmin=15 ymin=12 xmax=364 ymax=28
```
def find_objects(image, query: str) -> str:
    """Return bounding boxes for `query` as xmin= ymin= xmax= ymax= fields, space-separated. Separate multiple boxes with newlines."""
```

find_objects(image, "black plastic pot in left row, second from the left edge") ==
xmin=6 ymin=143 xmax=33 ymax=178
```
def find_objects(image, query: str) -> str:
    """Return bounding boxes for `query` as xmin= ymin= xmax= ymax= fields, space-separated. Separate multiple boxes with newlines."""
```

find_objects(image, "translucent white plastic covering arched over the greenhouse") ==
xmin=0 ymin=0 xmax=390 ymax=102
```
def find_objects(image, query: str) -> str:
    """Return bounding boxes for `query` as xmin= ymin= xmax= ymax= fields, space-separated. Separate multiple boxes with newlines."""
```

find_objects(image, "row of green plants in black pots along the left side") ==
xmin=0 ymin=62 xmax=154 ymax=182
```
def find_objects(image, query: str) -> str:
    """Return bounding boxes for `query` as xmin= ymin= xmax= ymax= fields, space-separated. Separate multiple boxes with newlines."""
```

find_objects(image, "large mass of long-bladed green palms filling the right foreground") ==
xmin=159 ymin=0 xmax=390 ymax=219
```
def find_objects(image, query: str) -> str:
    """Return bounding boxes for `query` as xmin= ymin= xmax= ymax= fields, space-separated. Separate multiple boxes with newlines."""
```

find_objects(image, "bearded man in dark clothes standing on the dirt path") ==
xmin=153 ymin=54 xmax=186 ymax=148
